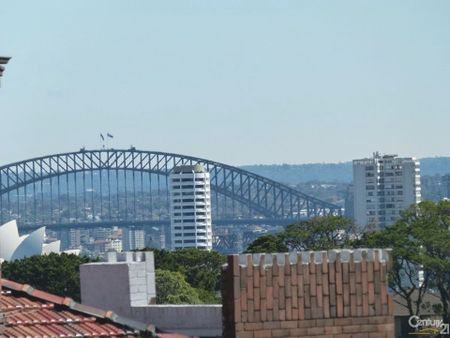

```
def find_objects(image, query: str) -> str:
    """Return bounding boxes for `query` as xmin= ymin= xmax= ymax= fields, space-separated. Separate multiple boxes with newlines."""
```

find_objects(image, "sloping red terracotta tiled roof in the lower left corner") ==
xmin=0 ymin=279 xmax=193 ymax=338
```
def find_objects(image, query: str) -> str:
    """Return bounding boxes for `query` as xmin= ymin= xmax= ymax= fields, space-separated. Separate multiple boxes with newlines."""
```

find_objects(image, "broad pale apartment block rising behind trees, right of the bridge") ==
xmin=353 ymin=152 xmax=421 ymax=228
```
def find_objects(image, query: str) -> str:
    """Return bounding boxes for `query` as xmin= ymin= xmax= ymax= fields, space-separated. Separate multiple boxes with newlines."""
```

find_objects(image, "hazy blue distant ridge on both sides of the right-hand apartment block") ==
xmin=241 ymin=157 xmax=450 ymax=184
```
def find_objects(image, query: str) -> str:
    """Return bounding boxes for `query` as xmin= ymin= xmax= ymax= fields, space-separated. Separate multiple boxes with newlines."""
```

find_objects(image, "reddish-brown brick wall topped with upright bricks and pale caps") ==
xmin=222 ymin=249 xmax=394 ymax=338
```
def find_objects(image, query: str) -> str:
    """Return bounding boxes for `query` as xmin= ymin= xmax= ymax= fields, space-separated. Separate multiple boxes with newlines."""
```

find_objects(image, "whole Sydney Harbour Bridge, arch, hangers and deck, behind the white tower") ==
xmin=0 ymin=148 xmax=341 ymax=250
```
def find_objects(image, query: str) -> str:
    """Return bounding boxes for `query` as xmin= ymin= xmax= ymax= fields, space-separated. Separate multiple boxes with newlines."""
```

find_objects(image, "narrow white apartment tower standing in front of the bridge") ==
xmin=170 ymin=165 xmax=212 ymax=250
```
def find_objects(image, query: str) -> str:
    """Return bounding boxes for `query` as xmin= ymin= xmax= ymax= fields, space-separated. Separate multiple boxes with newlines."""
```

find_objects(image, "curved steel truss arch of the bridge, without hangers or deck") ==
xmin=0 ymin=148 xmax=341 ymax=226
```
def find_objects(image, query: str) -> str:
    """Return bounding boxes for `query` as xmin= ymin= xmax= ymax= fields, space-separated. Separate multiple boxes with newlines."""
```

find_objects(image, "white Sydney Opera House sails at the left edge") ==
xmin=0 ymin=220 xmax=61 ymax=261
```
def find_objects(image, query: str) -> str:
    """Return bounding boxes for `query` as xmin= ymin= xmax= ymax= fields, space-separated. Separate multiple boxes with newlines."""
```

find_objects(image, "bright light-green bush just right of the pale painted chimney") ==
xmin=156 ymin=269 xmax=201 ymax=304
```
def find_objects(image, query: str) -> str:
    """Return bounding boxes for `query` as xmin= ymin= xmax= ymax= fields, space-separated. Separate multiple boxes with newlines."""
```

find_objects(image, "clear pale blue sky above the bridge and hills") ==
xmin=0 ymin=0 xmax=450 ymax=165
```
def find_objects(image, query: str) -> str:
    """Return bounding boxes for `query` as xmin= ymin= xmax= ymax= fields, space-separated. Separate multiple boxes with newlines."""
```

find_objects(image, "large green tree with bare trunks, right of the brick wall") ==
xmin=353 ymin=201 xmax=450 ymax=323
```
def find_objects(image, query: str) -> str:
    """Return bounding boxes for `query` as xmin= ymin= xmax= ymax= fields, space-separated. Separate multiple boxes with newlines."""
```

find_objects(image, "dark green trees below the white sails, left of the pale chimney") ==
xmin=1 ymin=253 xmax=93 ymax=301
